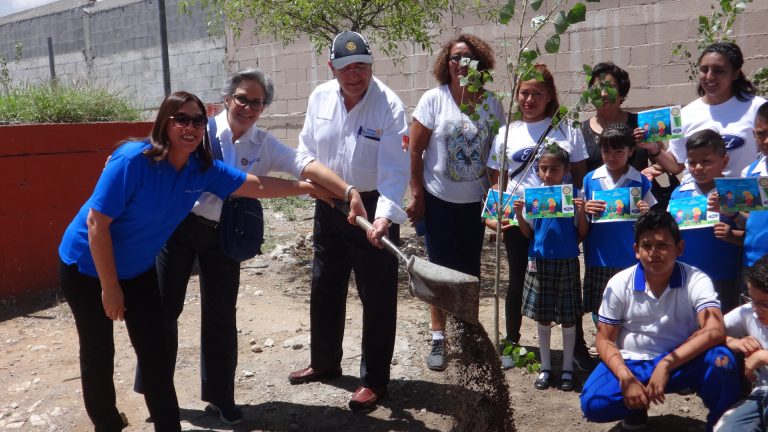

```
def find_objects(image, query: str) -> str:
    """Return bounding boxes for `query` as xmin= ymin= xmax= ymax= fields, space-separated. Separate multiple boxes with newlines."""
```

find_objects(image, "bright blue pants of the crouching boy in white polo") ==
xmin=581 ymin=346 xmax=741 ymax=431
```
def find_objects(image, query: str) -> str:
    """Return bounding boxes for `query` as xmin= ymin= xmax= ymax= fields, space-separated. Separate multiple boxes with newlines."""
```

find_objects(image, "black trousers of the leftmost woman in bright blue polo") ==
xmin=59 ymin=261 xmax=181 ymax=432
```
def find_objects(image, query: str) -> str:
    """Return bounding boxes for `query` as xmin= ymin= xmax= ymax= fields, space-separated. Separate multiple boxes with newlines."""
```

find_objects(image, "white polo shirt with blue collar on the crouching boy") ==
xmin=599 ymin=262 xmax=720 ymax=360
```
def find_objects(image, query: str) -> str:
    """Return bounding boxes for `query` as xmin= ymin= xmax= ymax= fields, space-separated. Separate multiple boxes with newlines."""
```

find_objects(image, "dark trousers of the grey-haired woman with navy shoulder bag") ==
xmin=134 ymin=213 xmax=240 ymax=407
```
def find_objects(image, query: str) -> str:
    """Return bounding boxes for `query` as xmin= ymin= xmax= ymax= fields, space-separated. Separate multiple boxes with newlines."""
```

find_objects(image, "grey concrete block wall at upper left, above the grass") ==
xmin=0 ymin=0 xmax=227 ymax=109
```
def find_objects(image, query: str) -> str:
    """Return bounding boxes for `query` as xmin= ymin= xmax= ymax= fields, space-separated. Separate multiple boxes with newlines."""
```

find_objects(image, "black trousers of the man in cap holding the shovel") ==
xmin=310 ymin=194 xmax=400 ymax=387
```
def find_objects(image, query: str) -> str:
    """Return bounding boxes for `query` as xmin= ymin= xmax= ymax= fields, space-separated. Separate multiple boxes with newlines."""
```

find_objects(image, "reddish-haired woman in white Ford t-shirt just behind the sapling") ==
xmin=486 ymin=64 xmax=588 ymax=352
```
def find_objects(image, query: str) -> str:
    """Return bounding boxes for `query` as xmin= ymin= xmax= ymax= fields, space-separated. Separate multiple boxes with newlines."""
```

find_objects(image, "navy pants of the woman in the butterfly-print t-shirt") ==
xmin=424 ymin=191 xmax=485 ymax=277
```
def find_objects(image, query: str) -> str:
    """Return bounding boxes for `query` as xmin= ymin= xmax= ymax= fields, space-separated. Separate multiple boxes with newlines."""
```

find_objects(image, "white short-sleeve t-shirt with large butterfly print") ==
xmin=413 ymin=85 xmax=504 ymax=203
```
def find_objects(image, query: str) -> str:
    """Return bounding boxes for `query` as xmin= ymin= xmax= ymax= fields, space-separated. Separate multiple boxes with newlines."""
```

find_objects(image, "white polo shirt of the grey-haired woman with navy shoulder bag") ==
xmin=192 ymin=110 xmax=314 ymax=222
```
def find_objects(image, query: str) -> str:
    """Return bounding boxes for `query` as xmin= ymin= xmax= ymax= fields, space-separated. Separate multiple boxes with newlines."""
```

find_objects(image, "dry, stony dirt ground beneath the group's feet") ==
xmin=0 ymin=201 xmax=706 ymax=432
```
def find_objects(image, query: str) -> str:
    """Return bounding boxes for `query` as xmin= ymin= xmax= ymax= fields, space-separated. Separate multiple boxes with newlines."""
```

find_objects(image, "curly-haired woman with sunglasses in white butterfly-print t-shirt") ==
xmin=407 ymin=34 xmax=504 ymax=371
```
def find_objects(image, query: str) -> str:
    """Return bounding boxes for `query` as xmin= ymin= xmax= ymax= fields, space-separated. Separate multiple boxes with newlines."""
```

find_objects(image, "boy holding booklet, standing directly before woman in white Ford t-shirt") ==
xmin=671 ymin=129 xmax=742 ymax=313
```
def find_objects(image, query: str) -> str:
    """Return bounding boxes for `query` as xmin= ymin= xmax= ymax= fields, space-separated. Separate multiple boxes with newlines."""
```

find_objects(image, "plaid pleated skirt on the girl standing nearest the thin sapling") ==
xmin=523 ymin=258 xmax=582 ymax=325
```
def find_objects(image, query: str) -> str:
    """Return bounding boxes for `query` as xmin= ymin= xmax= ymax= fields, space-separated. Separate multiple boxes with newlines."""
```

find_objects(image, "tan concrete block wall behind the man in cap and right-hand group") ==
xmin=227 ymin=0 xmax=768 ymax=145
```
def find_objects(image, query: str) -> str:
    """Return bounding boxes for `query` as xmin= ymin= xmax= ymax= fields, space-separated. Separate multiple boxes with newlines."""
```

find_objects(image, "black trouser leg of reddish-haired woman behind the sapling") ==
xmin=504 ymin=227 xmax=530 ymax=343
